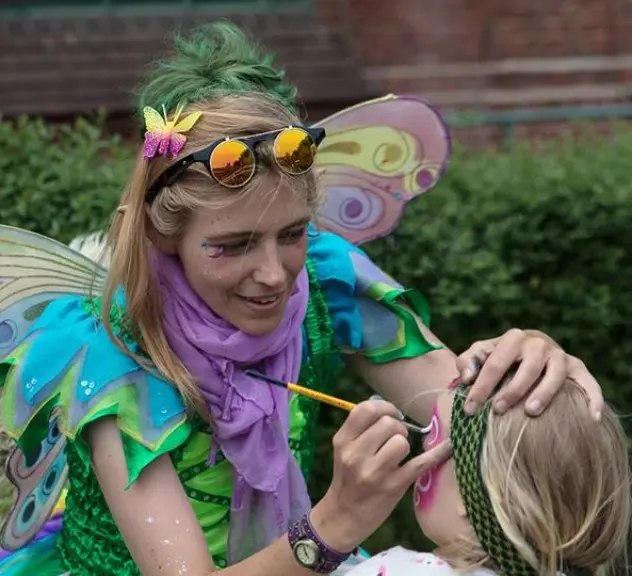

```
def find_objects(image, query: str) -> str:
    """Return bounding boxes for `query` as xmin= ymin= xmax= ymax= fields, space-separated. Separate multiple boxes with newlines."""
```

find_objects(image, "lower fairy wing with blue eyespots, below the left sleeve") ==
xmin=0 ymin=413 xmax=68 ymax=551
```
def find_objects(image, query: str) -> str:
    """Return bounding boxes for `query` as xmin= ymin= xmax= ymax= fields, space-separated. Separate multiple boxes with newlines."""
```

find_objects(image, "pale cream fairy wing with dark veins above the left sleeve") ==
xmin=0 ymin=225 xmax=107 ymax=360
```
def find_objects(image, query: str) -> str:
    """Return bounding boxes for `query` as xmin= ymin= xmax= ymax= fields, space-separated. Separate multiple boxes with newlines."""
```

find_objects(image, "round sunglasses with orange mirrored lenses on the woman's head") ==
xmin=146 ymin=126 xmax=325 ymax=203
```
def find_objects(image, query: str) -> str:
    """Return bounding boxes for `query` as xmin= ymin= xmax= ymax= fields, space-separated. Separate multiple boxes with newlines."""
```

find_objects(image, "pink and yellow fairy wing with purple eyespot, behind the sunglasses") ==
xmin=316 ymin=95 xmax=451 ymax=244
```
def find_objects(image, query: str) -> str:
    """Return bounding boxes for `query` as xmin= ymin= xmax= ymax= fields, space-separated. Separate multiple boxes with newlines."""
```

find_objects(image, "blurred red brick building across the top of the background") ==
xmin=0 ymin=0 xmax=632 ymax=143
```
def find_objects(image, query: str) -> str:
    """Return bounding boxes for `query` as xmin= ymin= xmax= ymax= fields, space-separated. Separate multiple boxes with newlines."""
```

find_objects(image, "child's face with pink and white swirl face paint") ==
xmin=413 ymin=392 xmax=470 ymax=546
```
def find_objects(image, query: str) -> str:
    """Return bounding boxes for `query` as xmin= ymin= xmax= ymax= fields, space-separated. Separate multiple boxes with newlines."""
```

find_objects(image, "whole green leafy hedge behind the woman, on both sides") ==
xmin=0 ymin=120 xmax=632 ymax=551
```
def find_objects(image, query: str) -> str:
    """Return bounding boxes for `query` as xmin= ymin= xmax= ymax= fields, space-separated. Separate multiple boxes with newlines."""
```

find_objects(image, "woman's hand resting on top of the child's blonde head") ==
xmin=457 ymin=329 xmax=604 ymax=419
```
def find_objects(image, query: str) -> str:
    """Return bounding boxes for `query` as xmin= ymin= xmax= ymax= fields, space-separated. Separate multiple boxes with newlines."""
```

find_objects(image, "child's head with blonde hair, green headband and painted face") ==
xmin=415 ymin=381 xmax=630 ymax=576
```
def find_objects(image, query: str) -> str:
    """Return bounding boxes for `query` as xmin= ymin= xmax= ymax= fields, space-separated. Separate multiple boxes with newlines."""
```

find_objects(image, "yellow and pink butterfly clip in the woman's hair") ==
xmin=143 ymin=105 xmax=202 ymax=160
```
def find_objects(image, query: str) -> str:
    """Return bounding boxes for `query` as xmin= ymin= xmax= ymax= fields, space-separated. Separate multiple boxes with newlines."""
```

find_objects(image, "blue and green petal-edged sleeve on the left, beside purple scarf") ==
xmin=0 ymin=296 xmax=191 ymax=484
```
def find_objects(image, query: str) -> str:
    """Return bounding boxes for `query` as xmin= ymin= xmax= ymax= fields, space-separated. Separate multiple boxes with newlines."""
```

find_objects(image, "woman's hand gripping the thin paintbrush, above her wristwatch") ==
xmin=311 ymin=400 xmax=451 ymax=552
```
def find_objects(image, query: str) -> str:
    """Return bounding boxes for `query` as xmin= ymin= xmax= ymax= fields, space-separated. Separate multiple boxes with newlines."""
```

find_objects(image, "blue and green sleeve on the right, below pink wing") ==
xmin=308 ymin=231 xmax=438 ymax=364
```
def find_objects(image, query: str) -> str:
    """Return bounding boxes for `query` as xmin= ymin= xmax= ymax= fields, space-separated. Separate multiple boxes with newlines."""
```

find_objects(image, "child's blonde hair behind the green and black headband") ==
xmin=437 ymin=380 xmax=630 ymax=576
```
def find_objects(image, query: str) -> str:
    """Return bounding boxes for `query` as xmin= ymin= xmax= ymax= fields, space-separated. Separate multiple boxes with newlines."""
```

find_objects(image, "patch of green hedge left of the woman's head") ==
xmin=0 ymin=113 xmax=131 ymax=242
